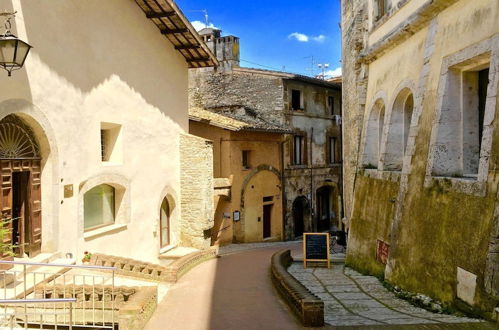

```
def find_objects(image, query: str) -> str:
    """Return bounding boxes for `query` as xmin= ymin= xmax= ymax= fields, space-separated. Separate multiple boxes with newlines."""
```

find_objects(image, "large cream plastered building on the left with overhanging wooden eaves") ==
xmin=0 ymin=0 xmax=216 ymax=262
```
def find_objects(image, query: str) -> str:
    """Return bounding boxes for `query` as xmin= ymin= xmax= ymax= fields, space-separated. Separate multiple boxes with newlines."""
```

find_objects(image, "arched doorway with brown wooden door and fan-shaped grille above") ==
xmin=0 ymin=115 xmax=42 ymax=257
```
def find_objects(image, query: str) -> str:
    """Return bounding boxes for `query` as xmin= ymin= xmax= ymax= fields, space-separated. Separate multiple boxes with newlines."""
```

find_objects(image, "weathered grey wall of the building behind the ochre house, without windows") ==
xmin=189 ymin=68 xmax=342 ymax=241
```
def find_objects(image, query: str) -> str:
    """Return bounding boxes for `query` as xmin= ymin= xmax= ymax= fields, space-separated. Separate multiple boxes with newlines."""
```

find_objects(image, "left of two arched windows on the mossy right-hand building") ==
xmin=364 ymin=99 xmax=385 ymax=168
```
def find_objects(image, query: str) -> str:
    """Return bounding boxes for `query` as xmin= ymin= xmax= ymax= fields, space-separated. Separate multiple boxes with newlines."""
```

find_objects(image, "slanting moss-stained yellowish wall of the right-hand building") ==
xmin=343 ymin=0 xmax=499 ymax=317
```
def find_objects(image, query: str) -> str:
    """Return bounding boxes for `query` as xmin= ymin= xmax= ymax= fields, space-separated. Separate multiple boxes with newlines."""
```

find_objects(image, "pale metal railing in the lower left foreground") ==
xmin=0 ymin=261 xmax=116 ymax=329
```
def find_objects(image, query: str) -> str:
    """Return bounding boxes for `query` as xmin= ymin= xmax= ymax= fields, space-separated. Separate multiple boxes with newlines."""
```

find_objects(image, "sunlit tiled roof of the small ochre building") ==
xmin=189 ymin=108 xmax=291 ymax=134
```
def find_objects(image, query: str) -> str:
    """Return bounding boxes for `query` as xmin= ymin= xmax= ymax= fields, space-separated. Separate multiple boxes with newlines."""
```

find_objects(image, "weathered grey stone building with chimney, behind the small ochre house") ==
xmin=189 ymin=29 xmax=342 ymax=240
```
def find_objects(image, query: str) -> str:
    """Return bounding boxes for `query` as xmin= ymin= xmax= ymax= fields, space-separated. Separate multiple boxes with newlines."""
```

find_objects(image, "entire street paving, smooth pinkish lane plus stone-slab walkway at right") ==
xmin=145 ymin=242 xmax=496 ymax=330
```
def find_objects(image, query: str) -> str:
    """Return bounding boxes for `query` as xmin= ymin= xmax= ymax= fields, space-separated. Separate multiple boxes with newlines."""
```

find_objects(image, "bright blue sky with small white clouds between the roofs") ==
xmin=176 ymin=0 xmax=341 ymax=75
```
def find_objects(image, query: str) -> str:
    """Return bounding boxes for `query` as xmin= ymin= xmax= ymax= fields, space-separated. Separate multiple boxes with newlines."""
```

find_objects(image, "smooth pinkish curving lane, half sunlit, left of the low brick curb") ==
xmin=145 ymin=243 xmax=301 ymax=330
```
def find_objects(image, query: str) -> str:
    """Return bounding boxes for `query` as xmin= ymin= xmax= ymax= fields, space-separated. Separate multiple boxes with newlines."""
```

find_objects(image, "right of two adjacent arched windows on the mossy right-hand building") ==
xmin=383 ymin=88 xmax=414 ymax=171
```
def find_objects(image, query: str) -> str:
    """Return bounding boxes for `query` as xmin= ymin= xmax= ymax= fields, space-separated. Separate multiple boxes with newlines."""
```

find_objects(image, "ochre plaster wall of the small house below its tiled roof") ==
xmin=190 ymin=120 xmax=283 ymax=245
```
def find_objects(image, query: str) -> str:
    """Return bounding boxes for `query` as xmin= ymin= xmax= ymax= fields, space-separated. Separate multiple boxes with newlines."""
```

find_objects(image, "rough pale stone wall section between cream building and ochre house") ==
xmin=180 ymin=134 xmax=214 ymax=249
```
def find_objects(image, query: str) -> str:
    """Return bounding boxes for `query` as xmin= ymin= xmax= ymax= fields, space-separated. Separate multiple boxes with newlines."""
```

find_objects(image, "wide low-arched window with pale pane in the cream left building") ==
xmin=83 ymin=184 xmax=115 ymax=230
